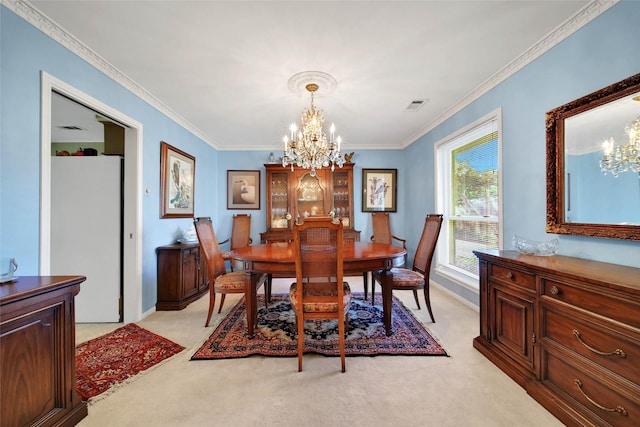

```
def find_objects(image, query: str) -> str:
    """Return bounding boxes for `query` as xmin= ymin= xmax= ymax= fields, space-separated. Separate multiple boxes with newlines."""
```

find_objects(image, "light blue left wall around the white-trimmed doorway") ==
xmin=0 ymin=6 xmax=221 ymax=312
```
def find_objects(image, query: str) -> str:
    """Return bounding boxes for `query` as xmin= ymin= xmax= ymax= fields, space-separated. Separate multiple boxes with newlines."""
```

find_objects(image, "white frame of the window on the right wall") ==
xmin=433 ymin=108 xmax=504 ymax=290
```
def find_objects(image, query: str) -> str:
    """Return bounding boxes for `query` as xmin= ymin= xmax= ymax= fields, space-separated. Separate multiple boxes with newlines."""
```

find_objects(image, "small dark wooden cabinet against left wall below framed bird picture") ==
xmin=156 ymin=243 xmax=209 ymax=310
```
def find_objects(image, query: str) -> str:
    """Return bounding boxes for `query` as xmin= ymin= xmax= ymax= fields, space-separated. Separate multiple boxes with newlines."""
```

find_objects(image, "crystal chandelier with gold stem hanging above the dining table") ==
xmin=282 ymin=83 xmax=344 ymax=176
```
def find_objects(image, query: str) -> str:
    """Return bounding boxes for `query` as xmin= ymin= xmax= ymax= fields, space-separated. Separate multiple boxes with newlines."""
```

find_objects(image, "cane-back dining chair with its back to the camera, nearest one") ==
xmin=289 ymin=217 xmax=351 ymax=372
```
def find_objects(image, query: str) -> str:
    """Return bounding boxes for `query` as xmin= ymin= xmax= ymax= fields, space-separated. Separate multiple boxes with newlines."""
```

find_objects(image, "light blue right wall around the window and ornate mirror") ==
xmin=404 ymin=1 xmax=640 ymax=303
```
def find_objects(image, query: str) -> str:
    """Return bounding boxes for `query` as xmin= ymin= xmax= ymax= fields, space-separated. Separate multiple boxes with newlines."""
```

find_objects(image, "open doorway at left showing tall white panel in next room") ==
xmin=51 ymin=91 xmax=125 ymax=323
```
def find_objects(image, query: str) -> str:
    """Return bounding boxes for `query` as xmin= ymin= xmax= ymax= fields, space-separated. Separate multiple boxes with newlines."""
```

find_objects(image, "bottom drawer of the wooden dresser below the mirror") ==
xmin=542 ymin=350 xmax=640 ymax=427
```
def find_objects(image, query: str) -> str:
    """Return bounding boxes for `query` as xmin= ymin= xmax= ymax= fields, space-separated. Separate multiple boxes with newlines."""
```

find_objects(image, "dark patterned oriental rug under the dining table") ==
xmin=191 ymin=294 xmax=447 ymax=360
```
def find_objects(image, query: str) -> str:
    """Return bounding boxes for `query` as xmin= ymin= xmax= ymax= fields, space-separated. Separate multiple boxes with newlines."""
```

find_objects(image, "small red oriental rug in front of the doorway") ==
xmin=76 ymin=323 xmax=184 ymax=400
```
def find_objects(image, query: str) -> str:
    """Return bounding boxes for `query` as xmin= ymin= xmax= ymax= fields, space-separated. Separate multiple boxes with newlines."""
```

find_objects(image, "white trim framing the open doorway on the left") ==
xmin=40 ymin=71 xmax=143 ymax=323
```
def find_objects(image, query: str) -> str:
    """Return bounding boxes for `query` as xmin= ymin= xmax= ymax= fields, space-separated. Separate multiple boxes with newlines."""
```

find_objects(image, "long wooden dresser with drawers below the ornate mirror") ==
xmin=473 ymin=251 xmax=640 ymax=426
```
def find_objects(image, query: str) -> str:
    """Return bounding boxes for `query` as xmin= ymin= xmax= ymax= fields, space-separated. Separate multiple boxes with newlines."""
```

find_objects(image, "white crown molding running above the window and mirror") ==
xmin=400 ymin=0 xmax=619 ymax=148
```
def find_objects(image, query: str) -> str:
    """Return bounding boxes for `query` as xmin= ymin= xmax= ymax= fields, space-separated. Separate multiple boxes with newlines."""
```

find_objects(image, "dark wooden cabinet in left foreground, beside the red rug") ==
xmin=0 ymin=276 xmax=87 ymax=426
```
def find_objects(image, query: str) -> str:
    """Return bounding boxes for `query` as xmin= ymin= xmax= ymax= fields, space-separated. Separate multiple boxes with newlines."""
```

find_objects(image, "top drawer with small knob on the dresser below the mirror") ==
xmin=542 ymin=279 xmax=640 ymax=328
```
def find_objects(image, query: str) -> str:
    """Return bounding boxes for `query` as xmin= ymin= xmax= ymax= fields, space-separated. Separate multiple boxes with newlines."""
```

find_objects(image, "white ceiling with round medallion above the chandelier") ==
xmin=36 ymin=0 xmax=590 ymax=152
